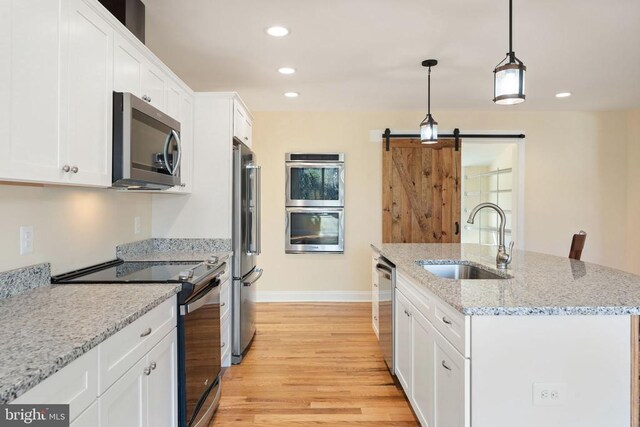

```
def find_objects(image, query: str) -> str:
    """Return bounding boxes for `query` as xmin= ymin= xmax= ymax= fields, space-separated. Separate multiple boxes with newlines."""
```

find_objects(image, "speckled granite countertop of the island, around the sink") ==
xmin=371 ymin=243 xmax=640 ymax=315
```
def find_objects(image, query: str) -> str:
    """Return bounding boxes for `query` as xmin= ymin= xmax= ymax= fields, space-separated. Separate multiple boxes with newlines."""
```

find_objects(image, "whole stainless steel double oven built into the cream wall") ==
xmin=285 ymin=153 xmax=344 ymax=253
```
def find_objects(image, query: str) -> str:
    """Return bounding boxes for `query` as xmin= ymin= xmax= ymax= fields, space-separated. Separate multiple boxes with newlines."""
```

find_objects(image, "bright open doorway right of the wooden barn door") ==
xmin=460 ymin=139 xmax=524 ymax=248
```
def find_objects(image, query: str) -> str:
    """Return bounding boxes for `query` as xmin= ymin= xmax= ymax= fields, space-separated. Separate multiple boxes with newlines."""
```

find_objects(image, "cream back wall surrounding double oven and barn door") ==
xmin=253 ymin=107 xmax=640 ymax=291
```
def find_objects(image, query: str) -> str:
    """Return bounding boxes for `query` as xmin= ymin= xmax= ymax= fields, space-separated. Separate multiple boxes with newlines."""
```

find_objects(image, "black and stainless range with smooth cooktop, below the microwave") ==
xmin=51 ymin=257 xmax=227 ymax=427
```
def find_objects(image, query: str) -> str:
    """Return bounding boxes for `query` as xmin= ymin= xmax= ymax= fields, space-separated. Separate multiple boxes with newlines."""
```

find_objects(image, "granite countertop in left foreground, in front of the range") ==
xmin=0 ymin=284 xmax=180 ymax=404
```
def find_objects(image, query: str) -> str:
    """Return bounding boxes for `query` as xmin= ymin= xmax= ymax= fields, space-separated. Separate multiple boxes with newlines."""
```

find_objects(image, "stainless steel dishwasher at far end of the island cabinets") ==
xmin=376 ymin=256 xmax=396 ymax=375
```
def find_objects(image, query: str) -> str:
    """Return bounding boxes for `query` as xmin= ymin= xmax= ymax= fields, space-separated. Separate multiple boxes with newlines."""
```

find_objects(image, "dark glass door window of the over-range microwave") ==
xmin=131 ymin=109 xmax=178 ymax=175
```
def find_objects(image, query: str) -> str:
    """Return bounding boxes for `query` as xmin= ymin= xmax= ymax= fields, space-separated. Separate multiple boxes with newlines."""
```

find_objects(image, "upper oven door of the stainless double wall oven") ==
xmin=287 ymin=163 xmax=344 ymax=206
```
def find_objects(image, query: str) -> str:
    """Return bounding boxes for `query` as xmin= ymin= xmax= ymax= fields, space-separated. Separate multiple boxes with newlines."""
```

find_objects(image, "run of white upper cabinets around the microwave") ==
xmin=0 ymin=0 xmax=193 ymax=192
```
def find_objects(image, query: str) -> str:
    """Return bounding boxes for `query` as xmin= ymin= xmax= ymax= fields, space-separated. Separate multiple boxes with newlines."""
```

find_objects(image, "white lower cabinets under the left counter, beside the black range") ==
xmin=10 ymin=297 xmax=178 ymax=427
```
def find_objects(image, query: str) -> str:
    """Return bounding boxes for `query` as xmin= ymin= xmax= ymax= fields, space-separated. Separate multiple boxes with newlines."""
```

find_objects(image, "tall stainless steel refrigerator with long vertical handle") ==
xmin=231 ymin=140 xmax=262 ymax=365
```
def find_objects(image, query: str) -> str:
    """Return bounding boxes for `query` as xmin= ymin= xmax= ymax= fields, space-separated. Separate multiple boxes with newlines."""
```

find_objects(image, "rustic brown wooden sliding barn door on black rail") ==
xmin=382 ymin=139 xmax=461 ymax=243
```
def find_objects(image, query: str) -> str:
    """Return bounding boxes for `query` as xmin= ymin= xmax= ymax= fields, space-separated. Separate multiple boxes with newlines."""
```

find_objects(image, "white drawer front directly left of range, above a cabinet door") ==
xmin=99 ymin=296 xmax=176 ymax=394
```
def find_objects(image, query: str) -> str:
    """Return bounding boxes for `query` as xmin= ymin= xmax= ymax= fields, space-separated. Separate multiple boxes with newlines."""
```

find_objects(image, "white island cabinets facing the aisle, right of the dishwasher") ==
xmin=395 ymin=288 xmax=470 ymax=427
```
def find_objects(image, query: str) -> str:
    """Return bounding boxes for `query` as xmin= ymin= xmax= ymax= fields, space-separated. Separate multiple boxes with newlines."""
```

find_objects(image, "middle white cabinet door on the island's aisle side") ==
xmin=411 ymin=310 xmax=438 ymax=427
